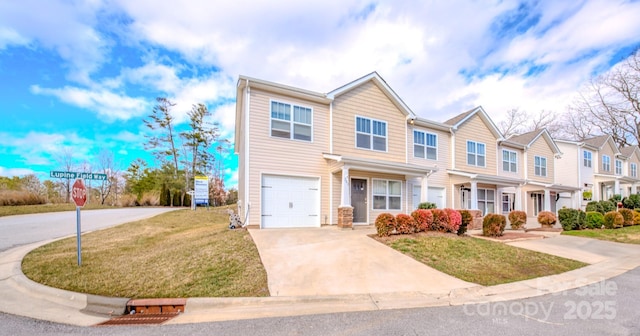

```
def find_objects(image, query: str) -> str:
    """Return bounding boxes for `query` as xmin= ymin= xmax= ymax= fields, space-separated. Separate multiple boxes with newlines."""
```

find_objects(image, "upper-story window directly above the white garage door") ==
xmin=271 ymin=101 xmax=312 ymax=141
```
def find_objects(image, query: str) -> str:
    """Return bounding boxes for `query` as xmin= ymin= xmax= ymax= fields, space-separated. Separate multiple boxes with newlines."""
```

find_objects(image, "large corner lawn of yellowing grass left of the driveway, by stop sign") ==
xmin=22 ymin=208 xmax=269 ymax=298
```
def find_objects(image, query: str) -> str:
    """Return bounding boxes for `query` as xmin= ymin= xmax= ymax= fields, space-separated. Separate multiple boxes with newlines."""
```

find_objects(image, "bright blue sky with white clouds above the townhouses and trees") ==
xmin=0 ymin=0 xmax=640 ymax=186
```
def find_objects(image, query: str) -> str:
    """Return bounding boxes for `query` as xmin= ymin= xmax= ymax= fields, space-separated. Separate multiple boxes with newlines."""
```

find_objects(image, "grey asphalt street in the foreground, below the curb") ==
xmin=0 ymin=269 xmax=640 ymax=336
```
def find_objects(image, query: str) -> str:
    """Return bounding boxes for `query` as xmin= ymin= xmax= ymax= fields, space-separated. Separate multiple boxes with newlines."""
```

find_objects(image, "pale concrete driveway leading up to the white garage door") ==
xmin=249 ymin=227 xmax=477 ymax=296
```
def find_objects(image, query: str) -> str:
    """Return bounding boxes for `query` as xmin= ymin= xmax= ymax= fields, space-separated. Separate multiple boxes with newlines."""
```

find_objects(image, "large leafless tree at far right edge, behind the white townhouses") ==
xmin=571 ymin=49 xmax=640 ymax=146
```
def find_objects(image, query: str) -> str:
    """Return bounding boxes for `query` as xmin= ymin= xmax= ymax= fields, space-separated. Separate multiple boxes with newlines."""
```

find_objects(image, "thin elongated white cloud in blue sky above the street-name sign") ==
xmin=31 ymin=85 xmax=148 ymax=122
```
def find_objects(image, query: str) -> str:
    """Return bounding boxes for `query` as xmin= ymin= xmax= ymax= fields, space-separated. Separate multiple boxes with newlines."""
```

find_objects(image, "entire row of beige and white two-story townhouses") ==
xmin=235 ymin=72 xmax=640 ymax=228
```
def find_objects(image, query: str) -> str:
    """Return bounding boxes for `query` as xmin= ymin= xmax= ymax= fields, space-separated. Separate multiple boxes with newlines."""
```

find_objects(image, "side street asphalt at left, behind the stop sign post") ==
xmin=0 ymin=208 xmax=175 ymax=252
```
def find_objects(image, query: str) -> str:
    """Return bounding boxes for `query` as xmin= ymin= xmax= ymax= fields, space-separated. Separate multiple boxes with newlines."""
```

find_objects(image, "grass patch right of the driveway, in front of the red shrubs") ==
xmin=379 ymin=235 xmax=587 ymax=286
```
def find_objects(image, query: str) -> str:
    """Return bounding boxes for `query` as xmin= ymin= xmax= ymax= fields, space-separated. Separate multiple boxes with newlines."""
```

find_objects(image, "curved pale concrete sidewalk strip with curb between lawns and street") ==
xmin=0 ymin=232 xmax=640 ymax=326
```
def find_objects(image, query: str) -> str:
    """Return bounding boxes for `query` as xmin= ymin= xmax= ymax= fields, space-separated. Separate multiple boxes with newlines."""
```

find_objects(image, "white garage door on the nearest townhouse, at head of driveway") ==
xmin=262 ymin=175 xmax=320 ymax=228
